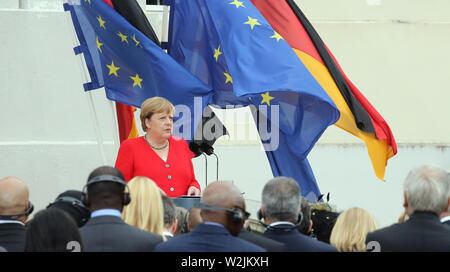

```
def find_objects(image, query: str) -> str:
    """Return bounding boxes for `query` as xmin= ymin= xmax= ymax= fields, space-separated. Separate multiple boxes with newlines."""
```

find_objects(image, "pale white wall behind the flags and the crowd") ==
xmin=0 ymin=0 xmax=450 ymax=226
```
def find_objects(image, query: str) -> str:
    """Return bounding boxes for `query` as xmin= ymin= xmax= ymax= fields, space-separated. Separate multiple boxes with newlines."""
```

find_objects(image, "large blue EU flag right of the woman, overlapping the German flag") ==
xmin=168 ymin=0 xmax=339 ymax=199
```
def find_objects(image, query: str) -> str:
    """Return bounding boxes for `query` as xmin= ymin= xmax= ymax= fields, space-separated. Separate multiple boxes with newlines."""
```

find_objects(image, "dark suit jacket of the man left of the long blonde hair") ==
xmin=80 ymin=215 xmax=162 ymax=252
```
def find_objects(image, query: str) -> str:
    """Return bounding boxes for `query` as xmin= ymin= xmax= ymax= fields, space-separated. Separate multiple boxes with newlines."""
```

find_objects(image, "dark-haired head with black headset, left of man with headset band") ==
xmin=47 ymin=190 xmax=91 ymax=228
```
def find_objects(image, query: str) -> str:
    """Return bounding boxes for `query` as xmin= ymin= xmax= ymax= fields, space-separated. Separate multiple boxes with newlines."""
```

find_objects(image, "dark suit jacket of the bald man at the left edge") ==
xmin=0 ymin=223 xmax=25 ymax=252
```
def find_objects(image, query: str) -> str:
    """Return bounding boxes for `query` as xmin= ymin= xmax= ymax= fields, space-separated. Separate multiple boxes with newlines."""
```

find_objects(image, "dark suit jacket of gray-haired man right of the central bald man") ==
xmin=264 ymin=224 xmax=337 ymax=252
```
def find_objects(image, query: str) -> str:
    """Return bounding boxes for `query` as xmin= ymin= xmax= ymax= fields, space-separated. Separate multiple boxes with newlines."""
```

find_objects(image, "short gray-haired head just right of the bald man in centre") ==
xmin=261 ymin=177 xmax=302 ymax=221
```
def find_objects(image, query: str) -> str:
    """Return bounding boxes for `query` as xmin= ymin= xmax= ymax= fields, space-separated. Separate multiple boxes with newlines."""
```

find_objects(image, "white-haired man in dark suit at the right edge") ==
xmin=366 ymin=166 xmax=450 ymax=252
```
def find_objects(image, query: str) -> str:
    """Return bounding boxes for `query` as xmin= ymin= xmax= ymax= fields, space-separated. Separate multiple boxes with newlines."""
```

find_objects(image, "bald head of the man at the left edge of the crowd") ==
xmin=0 ymin=177 xmax=28 ymax=215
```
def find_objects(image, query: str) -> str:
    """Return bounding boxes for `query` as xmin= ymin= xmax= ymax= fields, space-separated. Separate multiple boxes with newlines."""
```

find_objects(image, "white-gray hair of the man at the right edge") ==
xmin=403 ymin=165 xmax=450 ymax=215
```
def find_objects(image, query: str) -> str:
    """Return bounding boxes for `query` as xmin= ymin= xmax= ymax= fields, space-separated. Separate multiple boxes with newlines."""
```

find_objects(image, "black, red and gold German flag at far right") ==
xmin=251 ymin=0 xmax=397 ymax=180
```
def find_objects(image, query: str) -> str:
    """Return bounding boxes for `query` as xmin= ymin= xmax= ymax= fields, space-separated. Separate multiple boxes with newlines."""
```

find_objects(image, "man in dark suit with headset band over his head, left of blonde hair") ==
xmin=80 ymin=166 xmax=162 ymax=252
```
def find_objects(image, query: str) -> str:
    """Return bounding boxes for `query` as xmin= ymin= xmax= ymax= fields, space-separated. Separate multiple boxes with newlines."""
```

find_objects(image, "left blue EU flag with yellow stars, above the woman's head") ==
xmin=64 ymin=0 xmax=212 ymax=140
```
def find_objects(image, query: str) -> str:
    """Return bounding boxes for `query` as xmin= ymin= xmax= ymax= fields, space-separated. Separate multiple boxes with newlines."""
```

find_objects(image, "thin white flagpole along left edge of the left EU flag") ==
xmin=66 ymin=2 xmax=108 ymax=165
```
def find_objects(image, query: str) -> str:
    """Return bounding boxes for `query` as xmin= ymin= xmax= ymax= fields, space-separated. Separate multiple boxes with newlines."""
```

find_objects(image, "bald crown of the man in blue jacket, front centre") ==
xmin=202 ymin=181 xmax=245 ymax=208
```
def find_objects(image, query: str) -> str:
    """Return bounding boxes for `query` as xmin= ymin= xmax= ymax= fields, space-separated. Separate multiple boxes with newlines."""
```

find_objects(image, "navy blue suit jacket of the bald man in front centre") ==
xmin=155 ymin=223 xmax=266 ymax=252
